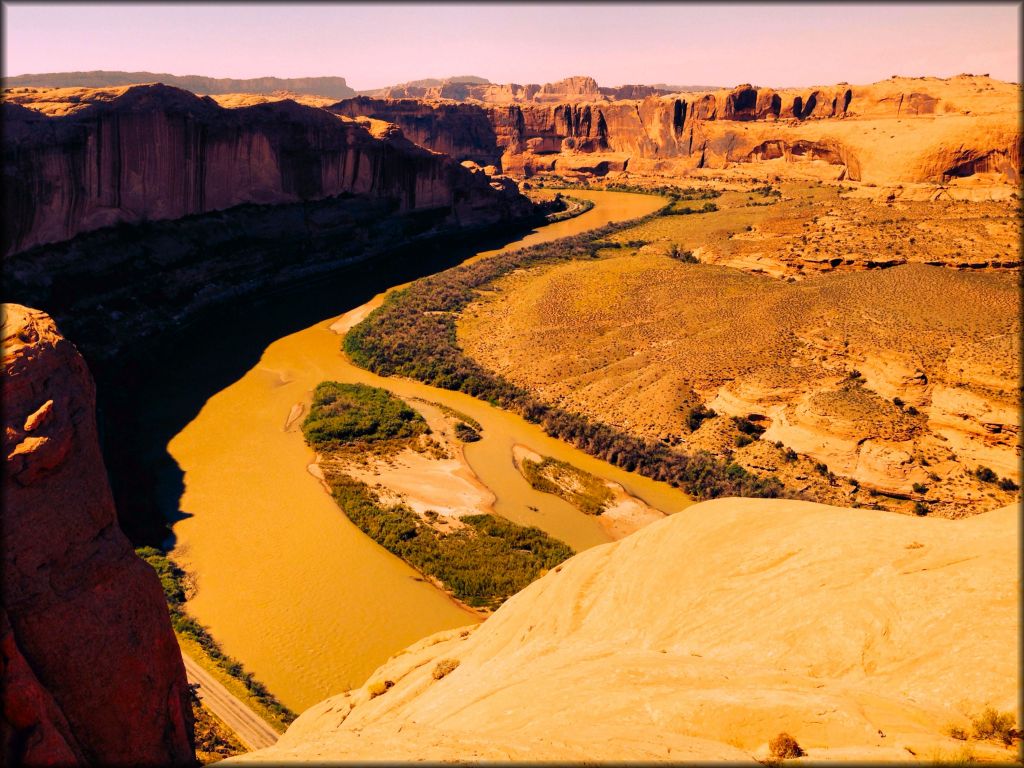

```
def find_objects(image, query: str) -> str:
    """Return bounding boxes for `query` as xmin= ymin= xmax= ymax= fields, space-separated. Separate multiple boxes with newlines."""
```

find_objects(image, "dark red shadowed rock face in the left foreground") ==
xmin=0 ymin=304 xmax=193 ymax=765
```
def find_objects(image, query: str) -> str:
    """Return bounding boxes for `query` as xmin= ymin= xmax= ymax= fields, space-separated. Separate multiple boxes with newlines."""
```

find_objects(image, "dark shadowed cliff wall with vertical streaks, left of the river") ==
xmin=3 ymin=85 xmax=529 ymax=254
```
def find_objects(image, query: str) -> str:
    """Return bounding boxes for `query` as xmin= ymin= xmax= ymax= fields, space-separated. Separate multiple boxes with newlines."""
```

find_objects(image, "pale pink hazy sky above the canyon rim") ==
xmin=3 ymin=2 xmax=1021 ymax=90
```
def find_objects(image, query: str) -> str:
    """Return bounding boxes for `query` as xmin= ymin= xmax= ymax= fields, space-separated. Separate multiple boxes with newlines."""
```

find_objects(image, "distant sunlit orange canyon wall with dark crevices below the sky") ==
xmin=330 ymin=76 xmax=1021 ymax=183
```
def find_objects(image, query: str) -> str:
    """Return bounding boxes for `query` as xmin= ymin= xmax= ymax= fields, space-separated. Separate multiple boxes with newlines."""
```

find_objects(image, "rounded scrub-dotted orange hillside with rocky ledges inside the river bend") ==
xmin=458 ymin=198 xmax=1020 ymax=516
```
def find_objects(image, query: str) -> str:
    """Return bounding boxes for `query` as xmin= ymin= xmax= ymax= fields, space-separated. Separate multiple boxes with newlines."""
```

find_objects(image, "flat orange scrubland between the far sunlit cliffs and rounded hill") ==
xmin=598 ymin=181 xmax=1022 ymax=280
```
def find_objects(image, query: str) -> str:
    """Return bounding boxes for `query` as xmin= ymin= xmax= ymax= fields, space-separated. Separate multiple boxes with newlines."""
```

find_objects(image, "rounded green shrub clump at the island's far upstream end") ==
xmin=302 ymin=381 xmax=428 ymax=451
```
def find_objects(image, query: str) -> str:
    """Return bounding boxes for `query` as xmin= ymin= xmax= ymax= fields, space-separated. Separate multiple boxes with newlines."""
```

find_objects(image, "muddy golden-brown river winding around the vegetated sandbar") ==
xmin=168 ymin=191 xmax=690 ymax=712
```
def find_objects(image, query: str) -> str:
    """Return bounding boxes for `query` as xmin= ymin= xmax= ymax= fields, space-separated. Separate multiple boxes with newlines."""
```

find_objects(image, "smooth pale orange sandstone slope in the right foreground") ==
xmin=240 ymin=499 xmax=1020 ymax=763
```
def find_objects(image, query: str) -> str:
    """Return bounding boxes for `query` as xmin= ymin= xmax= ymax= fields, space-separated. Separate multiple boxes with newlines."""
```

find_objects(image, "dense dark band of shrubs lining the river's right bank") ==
xmin=343 ymin=207 xmax=785 ymax=499
